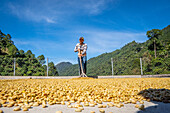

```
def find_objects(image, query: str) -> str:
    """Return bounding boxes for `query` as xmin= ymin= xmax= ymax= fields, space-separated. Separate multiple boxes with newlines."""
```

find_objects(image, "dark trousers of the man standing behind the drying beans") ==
xmin=78 ymin=56 xmax=87 ymax=75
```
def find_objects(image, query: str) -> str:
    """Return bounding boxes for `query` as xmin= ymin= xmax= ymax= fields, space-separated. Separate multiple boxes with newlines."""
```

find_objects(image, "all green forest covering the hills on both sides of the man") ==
xmin=0 ymin=25 xmax=170 ymax=76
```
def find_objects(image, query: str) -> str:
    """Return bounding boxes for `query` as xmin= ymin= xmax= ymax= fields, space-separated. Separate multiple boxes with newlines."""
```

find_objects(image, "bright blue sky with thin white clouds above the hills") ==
xmin=0 ymin=0 xmax=170 ymax=63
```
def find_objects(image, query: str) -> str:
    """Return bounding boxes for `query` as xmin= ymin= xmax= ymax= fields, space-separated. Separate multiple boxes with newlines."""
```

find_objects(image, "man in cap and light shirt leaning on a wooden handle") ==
xmin=74 ymin=37 xmax=87 ymax=76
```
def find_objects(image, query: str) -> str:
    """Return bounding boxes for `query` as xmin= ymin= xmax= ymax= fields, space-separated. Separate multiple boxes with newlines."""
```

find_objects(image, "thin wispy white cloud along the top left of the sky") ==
xmin=7 ymin=0 xmax=116 ymax=23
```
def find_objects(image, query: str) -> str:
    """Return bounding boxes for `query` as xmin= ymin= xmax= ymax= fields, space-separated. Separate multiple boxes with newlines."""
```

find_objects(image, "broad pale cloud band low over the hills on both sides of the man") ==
xmin=14 ymin=29 xmax=147 ymax=64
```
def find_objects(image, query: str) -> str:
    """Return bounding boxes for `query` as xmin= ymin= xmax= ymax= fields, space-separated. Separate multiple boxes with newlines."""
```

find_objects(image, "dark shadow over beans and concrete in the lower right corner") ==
xmin=137 ymin=88 xmax=170 ymax=113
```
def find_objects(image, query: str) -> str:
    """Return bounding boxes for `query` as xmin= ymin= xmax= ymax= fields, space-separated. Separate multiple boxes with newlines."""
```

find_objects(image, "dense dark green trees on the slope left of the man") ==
xmin=0 ymin=31 xmax=58 ymax=76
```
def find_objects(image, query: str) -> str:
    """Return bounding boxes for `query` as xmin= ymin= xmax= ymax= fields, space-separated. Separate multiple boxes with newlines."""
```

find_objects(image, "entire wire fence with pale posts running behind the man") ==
xmin=0 ymin=57 xmax=170 ymax=76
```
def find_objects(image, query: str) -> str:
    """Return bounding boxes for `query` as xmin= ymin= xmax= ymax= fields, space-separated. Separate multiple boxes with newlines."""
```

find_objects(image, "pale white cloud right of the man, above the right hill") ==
xmin=74 ymin=30 xmax=147 ymax=56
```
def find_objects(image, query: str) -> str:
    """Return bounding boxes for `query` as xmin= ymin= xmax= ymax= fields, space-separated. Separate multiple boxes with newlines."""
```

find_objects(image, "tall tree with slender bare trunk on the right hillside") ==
xmin=146 ymin=29 xmax=162 ymax=58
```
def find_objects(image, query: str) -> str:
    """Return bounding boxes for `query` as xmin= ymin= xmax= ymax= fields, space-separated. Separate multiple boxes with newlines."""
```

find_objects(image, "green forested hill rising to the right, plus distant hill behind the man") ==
xmin=58 ymin=25 xmax=170 ymax=76
